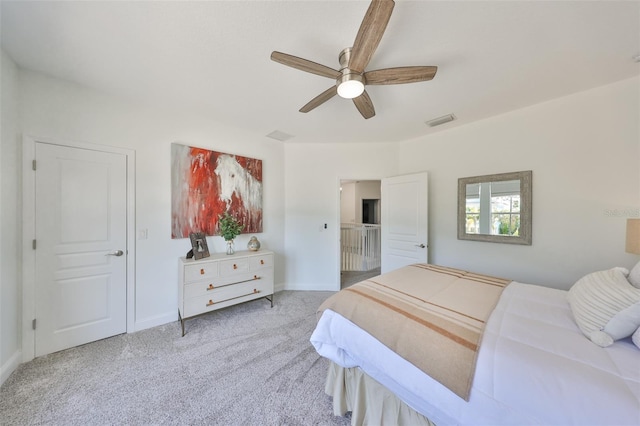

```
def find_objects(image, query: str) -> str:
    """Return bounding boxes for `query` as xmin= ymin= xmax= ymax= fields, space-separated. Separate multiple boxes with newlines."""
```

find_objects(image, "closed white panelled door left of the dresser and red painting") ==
xmin=35 ymin=142 xmax=127 ymax=356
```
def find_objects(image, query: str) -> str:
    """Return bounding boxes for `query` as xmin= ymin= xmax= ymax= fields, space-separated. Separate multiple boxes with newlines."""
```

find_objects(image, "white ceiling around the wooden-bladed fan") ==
xmin=1 ymin=0 xmax=640 ymax=143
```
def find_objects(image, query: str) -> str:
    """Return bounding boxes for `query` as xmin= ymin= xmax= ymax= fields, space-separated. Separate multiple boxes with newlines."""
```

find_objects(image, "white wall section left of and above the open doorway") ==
xmin=285 ymin=143 xmax=397 ymax=290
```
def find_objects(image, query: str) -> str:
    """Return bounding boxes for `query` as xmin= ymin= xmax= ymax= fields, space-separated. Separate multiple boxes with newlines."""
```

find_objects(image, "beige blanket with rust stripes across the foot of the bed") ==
xmin=318 ymin=264 xmax=511 ymax=400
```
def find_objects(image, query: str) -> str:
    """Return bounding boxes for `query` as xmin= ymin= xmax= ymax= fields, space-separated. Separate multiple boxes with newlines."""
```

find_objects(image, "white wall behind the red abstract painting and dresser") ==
xmin=20 ymin=71 xmax=284 ymax=330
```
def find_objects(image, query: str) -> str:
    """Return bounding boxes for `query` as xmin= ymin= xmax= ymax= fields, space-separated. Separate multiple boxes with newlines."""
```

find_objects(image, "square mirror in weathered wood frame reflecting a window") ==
xmin=458 ymin=170 xmax=532 ymax=245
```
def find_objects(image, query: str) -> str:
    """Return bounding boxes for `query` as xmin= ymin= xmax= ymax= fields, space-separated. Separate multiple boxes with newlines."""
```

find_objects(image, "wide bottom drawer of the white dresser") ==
xmin=184 ymin=280 xmax=273 ymax=318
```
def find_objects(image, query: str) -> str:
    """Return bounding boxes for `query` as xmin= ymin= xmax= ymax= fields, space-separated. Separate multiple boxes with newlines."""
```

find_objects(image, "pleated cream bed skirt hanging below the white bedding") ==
xmin=324 ymin=362 xmax=435 ymax=426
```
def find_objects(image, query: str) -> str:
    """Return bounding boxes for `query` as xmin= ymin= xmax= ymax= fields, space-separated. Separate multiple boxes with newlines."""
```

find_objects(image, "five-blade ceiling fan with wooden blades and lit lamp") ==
xmin=271 ymin=0 xmax=438 ymax=118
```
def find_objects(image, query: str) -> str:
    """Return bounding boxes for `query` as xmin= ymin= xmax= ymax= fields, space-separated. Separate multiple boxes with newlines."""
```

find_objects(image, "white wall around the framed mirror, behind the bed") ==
xmin=399 ymin=78 xmax=640 ymax=288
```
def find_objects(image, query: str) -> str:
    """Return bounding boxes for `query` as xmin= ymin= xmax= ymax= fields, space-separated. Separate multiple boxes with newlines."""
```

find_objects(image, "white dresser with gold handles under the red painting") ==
xmin=178 ymin=250 xmax=273 ymax=336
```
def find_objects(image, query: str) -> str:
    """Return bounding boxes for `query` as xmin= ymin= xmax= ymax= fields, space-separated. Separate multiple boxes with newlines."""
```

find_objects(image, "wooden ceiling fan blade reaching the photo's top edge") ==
xmin=349 ymin=0 xmax=395 ymax=73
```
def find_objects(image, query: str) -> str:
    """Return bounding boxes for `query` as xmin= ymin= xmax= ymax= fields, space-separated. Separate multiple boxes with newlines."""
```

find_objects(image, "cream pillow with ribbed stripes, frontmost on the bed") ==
xmin=568 ymin=268 xmax=640 ymax=347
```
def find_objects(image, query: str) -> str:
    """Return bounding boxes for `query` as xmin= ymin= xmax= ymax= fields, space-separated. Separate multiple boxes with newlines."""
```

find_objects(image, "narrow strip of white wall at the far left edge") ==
xmin=0 ymin=51 xmax=22 ymax=383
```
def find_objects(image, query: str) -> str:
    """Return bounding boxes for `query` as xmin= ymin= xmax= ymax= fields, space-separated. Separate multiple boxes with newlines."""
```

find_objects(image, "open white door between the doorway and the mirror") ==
xmin=380 ymin=172 xmax=428 ymax=273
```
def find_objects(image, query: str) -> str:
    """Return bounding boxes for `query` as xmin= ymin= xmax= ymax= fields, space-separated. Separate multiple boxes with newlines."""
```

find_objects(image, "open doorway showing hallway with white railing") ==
xmin=339 ymin=179 xmax=381 ymax=288
